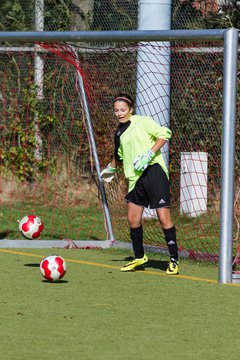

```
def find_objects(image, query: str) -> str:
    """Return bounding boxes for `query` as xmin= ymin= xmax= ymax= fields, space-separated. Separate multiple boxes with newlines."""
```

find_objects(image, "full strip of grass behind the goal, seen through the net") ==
xmin=0 ymin=201 xmax=236 ymax=268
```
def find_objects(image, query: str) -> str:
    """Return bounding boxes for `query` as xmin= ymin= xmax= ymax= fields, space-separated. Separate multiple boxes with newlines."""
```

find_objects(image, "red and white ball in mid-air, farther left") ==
xmin=19 ymin=215 xmax=43 ymax=239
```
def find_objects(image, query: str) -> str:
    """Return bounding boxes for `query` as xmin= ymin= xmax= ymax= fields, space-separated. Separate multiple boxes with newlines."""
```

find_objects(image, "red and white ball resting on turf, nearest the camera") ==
xmin=40 ymin=255 xmax=67 ymax=281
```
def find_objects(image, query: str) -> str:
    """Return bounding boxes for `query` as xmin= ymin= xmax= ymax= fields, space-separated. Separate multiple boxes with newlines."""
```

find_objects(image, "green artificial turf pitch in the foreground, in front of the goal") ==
xmin=0 ymin=249 xmax=240 ymax=360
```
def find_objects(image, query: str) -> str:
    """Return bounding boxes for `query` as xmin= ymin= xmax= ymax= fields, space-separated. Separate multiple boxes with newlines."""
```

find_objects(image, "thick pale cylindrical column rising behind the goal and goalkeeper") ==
xmin=136 ymin=0 xmax=172 ymax=218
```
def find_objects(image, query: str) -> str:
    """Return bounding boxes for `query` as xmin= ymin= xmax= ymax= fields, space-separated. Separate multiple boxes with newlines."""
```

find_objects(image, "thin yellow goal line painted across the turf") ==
xmin=0 ymin=249 xmax=240 ymax=287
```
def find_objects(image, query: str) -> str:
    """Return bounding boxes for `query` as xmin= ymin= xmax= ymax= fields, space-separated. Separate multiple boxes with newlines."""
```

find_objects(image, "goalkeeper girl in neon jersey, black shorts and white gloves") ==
xmin=101 ymin=93 xmax=179 ymax=275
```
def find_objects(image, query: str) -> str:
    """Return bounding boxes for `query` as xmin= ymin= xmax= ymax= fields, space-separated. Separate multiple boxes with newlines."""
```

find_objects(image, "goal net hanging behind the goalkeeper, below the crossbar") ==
xmin=0 ymin=41 xmax=240 ymax=261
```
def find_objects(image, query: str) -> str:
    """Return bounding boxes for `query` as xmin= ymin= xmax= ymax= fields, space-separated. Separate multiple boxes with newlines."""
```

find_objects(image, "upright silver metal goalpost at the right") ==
xmin=219 ymin=29 xmax=238 ymax=283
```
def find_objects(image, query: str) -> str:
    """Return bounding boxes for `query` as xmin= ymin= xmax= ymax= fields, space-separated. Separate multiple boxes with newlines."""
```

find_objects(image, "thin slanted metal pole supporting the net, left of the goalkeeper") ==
xmin=77 ymin=71 xmax=114 ymax=241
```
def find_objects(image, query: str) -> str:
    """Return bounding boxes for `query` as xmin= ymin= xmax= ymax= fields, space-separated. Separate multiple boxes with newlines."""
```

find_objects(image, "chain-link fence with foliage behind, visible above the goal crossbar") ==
xmin=0 ymin=0 xmax=236 ymax=31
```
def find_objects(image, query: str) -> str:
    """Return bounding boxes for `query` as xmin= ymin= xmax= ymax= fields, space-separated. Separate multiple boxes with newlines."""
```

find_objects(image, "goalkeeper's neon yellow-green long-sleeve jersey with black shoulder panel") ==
xmin=114 ymin=115 xmax=172 ymax=191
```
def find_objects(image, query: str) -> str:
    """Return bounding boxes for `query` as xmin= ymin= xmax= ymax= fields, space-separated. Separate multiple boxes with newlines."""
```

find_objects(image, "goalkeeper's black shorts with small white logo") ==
xmin=125 ymin=164 xmax=170 ymax=209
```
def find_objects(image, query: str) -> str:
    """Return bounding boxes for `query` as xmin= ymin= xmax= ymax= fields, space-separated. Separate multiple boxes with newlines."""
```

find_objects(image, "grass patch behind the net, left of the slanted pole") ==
xmin=0 ymin=203 xmax=106 ymax=240
